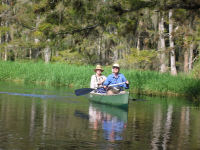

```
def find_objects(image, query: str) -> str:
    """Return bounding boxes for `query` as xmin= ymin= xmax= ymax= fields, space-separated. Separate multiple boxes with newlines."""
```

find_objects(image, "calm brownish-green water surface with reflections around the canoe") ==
xmin=0 ymin=82 xmax=200 ymax=150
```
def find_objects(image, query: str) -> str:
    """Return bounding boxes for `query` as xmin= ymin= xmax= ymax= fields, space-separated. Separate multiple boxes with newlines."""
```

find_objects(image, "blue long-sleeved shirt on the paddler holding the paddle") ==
xmin=103 ymin=73 xmax=129 ymax=89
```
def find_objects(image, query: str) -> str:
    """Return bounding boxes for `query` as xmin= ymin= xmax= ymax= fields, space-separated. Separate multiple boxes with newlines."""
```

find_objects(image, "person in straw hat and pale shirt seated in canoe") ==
xmin=90 ymin=65 xmax=106 ymax=93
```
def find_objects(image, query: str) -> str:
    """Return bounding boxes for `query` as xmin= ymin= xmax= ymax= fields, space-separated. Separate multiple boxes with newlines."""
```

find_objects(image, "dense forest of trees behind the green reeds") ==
xmin=0 ymin=0 xmax=200 ymax=77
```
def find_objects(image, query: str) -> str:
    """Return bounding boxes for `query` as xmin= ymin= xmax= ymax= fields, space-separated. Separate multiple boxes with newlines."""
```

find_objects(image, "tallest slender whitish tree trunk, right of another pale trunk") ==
xmin=169 ymin=9 xmax=177 ymax=75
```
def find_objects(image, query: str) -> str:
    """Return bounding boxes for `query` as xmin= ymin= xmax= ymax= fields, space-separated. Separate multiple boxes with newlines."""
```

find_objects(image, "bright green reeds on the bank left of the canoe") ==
xmin=0 ymin=61 xmax=92 ymax=87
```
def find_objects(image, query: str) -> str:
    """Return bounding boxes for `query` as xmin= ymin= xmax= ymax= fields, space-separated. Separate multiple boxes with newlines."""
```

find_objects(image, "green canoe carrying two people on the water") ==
xmin=88 ymin=92 xmax=129 ymax=108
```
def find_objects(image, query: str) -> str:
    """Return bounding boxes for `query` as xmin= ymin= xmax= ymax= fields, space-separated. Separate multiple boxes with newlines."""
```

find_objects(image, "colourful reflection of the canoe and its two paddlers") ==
xmin=89 ymin=103 xmax=128 ymax=142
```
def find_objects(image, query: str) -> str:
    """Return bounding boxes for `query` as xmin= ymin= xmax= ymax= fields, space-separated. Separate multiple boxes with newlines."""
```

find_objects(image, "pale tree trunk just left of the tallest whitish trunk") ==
xmin=158 ymin=16 xmax=167 ymax=73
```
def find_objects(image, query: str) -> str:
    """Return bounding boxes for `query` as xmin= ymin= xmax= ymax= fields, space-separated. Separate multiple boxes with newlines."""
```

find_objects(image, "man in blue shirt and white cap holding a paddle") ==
xmin=103 ymin=64 xmax=129 ymax=95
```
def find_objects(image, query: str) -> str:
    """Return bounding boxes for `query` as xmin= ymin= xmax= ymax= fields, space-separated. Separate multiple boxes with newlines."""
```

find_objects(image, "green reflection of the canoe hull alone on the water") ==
xmin=90 ymin=102 xmax=128 ymax=123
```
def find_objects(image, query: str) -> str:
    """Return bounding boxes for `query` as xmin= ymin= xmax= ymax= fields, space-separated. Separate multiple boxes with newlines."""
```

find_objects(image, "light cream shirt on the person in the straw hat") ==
xmin=90 ymin=75 xmax=106 ymax=89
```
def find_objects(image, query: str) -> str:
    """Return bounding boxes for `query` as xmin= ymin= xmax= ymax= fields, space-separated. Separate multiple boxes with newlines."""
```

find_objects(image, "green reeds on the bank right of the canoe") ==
xmin=124 ymin=70 xmax=200 ymax=97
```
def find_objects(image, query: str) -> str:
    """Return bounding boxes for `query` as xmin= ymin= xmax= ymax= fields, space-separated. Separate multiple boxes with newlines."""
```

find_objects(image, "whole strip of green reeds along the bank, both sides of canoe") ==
xmin=0 ymin=61 xmax=200 ymax=100
